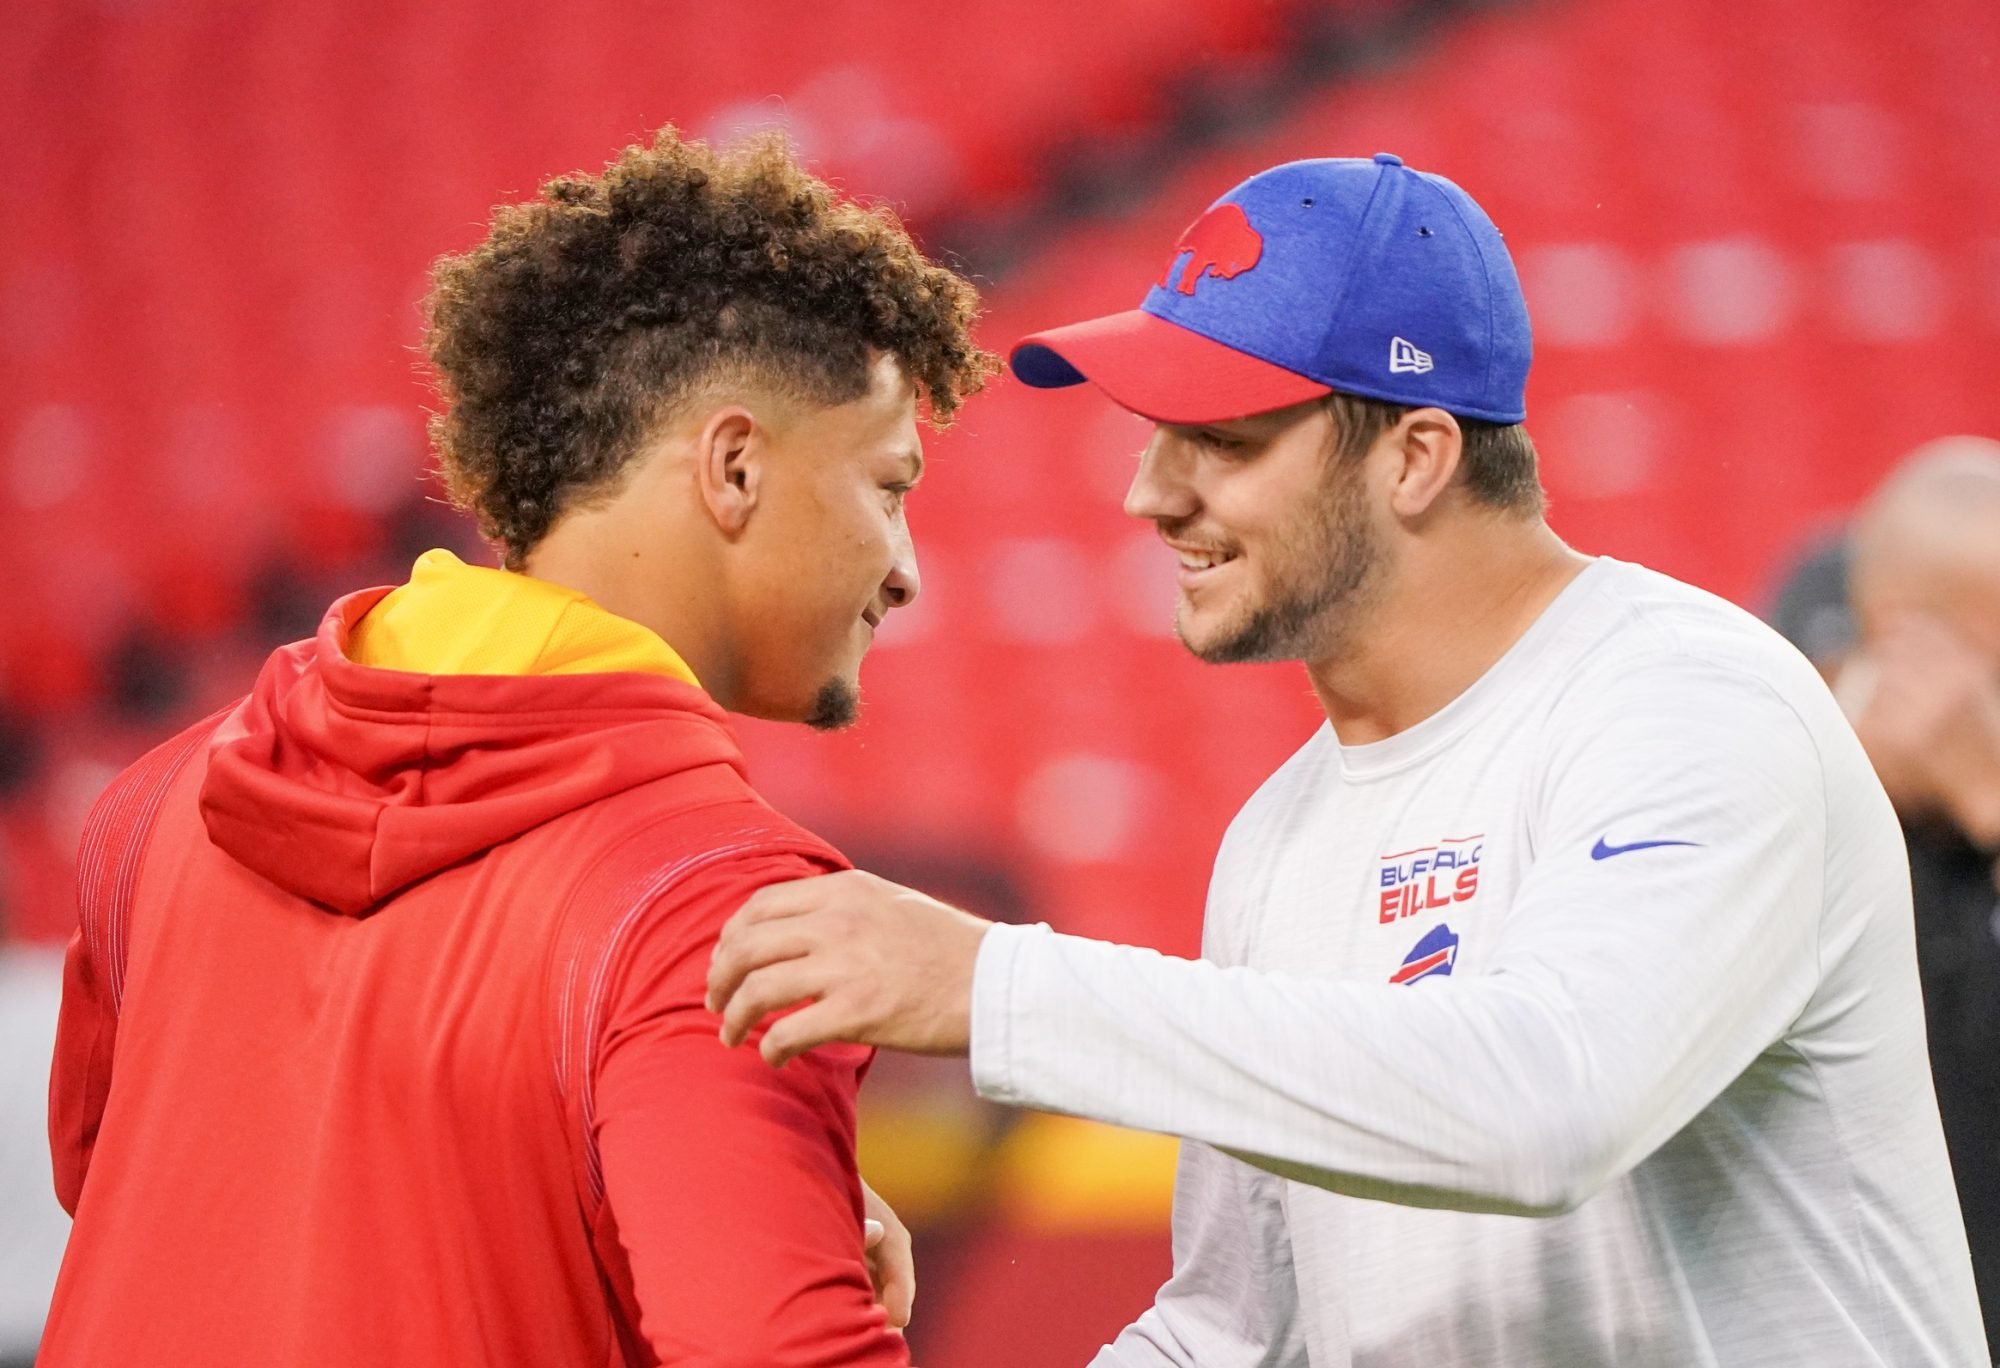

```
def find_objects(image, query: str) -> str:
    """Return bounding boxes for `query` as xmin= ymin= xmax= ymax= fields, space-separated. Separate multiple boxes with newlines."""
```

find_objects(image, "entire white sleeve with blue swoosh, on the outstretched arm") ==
xmin=972 ymin=656 xmax=1826 ymax=1214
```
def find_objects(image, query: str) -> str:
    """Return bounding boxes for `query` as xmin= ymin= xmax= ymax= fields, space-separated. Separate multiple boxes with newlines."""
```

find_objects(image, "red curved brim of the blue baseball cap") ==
xmin=1008 ymin=308 xmax=1332 ymax=422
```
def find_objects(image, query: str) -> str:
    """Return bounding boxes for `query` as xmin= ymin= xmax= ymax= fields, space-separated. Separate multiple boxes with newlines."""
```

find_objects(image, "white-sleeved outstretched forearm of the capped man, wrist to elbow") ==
xmin=972 ymin=928 xmax=1816 ymax=1214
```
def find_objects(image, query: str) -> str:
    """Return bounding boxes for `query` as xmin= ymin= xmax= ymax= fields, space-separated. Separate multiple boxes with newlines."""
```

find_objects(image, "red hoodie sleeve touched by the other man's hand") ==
xmin=592 ymin=854 xmax=908 ymax=1368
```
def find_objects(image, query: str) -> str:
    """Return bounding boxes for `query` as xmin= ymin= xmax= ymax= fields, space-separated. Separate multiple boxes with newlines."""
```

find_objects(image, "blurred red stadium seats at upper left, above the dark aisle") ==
xmin=0 ymin=0 xmax=1304 ymax=680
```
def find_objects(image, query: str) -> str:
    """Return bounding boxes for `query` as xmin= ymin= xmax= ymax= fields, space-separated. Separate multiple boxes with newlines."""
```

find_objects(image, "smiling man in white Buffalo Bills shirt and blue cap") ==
xmin=710 ymin=154 xmax=1988 ymax=1368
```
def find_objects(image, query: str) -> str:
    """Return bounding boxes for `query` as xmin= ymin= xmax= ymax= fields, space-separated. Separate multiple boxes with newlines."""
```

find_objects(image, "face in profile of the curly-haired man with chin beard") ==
xmin=730 ymin=356 xmax=924 ymax=728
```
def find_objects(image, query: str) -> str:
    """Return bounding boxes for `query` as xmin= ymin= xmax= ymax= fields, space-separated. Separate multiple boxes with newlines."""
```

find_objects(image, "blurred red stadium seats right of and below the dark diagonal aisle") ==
xmin=766 ymin=0 xmax=2000 ymax=968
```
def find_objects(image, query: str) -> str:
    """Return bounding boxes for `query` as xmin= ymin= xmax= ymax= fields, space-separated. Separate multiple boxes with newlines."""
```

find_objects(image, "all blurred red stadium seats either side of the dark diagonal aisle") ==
xmin=0 ymin=0 xmax=2000 ymax=984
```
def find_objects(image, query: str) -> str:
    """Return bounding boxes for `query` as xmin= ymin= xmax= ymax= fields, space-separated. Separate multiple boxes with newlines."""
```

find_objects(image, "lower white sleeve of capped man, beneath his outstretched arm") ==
xmin=1092 ymin=1142 xmax=1306 ymax=1368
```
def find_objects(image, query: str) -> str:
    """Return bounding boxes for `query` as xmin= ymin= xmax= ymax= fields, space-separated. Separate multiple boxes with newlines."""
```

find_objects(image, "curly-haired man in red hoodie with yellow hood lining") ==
xmin=40 ymin=132 xmax=990 ymax=1368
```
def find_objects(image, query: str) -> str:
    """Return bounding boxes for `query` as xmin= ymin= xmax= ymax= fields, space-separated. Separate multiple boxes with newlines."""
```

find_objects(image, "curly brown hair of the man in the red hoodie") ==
xmin=424 ymin=128 xmax=998 ymax=568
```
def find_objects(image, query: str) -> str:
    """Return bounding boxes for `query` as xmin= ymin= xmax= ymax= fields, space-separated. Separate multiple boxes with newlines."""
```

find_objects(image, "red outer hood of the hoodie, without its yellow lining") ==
xmin=200 ymin=588 xmax=742 ymax=916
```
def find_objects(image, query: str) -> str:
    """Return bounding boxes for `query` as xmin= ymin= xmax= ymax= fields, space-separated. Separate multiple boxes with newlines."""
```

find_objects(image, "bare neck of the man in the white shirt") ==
xmin=1306 ymin=514 xmax=1590 ymax=746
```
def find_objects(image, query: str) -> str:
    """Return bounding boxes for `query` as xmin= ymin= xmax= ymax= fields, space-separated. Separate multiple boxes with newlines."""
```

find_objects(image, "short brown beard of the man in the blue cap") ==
xmin=1174 ymin=458 xmax=1382 ymax=664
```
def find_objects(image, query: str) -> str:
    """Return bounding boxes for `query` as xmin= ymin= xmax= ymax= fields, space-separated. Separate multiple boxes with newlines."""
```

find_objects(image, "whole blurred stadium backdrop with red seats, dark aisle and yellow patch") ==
xmin=0 ymin=0 xmax=2000 ymax=1364
